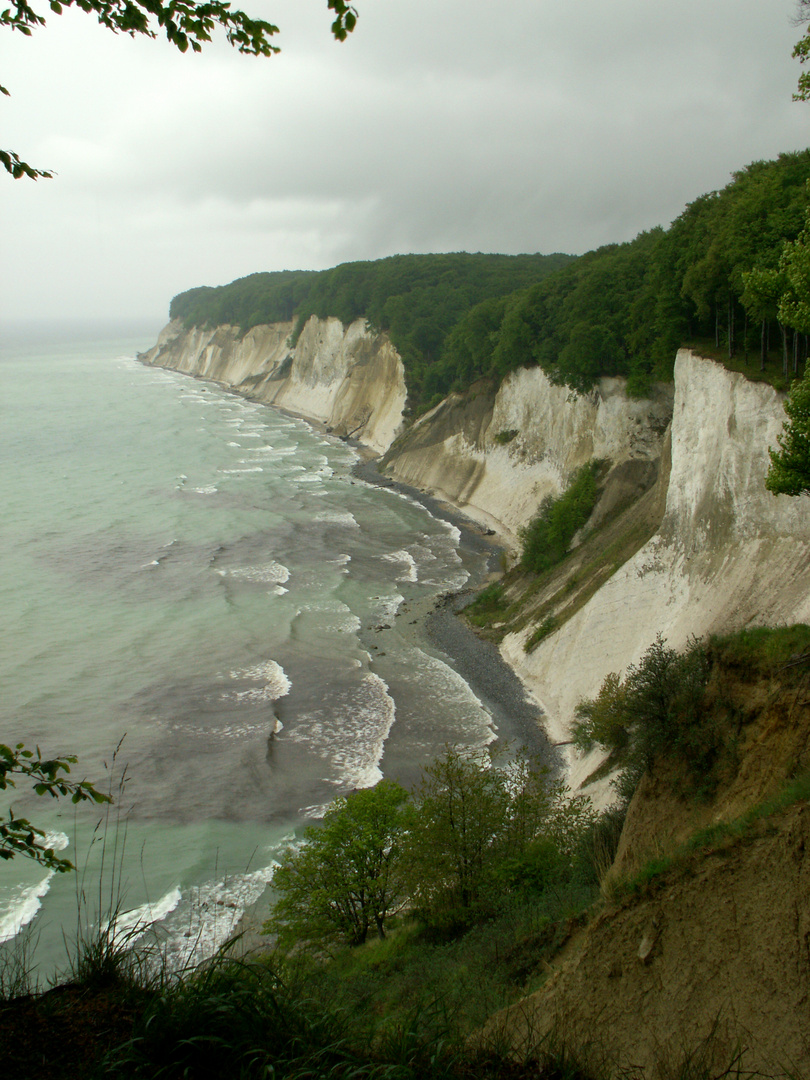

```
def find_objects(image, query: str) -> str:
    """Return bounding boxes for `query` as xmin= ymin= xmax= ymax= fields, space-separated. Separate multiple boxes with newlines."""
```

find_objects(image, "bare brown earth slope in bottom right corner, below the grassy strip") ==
xmin=486 ymin=802 xmax=810 ymax=1080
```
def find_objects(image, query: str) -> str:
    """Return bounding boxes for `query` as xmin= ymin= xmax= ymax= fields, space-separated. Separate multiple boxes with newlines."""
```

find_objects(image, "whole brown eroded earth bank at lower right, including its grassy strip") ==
xmin=488 ymin=646 xmax=810 ymax=1080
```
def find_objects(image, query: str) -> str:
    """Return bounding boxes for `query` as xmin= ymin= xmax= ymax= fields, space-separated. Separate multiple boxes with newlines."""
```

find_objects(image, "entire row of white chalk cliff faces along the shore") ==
xmin=141 ymin=318 xmax=810 ymax=798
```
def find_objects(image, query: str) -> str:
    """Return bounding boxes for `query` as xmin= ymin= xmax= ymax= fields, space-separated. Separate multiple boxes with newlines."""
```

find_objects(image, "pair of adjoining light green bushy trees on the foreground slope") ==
xmin=266 ymin=748 xmax=595 ymax=951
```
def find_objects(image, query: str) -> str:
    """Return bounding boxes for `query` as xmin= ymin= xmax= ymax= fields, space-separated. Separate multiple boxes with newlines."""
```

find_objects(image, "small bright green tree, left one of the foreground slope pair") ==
xmin=265 ymin=780 xmax=409 ymax=945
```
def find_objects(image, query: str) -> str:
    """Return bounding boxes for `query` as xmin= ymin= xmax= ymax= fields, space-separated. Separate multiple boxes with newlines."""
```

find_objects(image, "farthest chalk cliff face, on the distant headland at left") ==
xmin=139 ymin=316 xmax=406 ymax=454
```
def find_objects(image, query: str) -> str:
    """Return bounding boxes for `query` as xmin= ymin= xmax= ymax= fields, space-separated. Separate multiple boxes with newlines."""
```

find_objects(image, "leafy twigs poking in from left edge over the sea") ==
xmin=0 ymin=743 xmax=112 ymax=873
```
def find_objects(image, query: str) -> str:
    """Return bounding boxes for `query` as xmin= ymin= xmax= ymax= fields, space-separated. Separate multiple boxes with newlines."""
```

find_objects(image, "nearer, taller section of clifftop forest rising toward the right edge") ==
xmin=434 ymin=150 xmax=810 ymax=399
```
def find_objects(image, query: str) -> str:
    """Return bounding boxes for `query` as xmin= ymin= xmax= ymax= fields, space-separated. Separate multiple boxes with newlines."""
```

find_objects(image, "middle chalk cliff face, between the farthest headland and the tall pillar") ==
xmin=384 ymin=367 xmax=672 ymax=548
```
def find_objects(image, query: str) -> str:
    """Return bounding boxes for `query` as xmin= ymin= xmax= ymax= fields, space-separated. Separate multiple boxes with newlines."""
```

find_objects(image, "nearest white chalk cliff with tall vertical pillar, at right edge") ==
xmin=501 ymin=350 xmax=810 ymax=799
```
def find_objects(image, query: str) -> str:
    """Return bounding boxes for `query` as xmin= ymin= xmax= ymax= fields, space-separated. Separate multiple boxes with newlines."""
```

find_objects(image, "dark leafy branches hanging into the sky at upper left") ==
xmin=0 ymin=0 xmax=357 ymax=180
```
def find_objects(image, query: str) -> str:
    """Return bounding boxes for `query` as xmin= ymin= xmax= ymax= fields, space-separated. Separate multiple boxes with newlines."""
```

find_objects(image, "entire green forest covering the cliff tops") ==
xmin=170 ymin=149 xmax=810 ymax=410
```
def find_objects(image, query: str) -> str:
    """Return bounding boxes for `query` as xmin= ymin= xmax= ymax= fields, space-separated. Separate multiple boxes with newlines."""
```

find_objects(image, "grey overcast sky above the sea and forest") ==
xmin=0 ymin=0 xmax=810 ymax=325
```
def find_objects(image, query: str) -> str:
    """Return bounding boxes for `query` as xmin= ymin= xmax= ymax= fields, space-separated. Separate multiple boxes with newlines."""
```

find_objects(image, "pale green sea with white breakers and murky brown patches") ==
xmin=0 ymin=324 xmax=546 ymax=981
